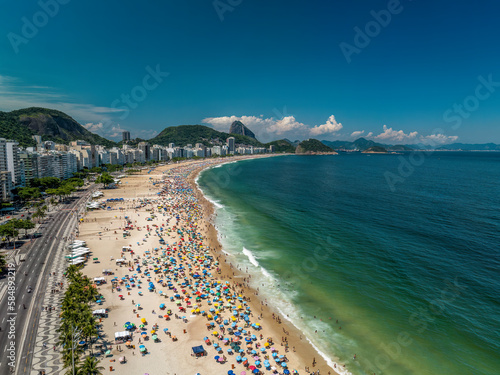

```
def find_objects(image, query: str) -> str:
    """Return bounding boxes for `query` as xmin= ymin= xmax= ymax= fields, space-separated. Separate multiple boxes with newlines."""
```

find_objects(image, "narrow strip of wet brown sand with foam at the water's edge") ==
xmin=189 ymin=154 xmax=351 ymax=375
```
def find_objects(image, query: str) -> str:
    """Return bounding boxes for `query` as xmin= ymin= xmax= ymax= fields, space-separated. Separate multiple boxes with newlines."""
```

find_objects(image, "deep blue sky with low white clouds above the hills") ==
xmin=0 ymin=0 xmax=500 ymax=144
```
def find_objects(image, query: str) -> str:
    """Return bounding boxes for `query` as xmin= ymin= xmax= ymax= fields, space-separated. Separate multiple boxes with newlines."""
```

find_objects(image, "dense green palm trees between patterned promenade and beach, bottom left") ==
xmin=57 ymin=265 xmax=103 ymax=375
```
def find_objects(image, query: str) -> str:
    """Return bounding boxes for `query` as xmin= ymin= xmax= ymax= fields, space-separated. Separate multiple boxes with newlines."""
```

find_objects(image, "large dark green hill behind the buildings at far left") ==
xmin=0 ymin=107 xmax=116 ymax=147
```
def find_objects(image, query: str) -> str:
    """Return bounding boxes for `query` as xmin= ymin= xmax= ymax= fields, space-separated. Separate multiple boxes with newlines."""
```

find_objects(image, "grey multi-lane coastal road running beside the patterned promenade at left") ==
xmin=0 ymin=187 xmax=95 ymax=375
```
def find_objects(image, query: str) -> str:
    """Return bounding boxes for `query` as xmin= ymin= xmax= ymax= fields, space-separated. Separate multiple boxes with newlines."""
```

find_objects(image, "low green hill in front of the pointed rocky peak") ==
xmin=148 ymin=125 xmax=264 ymax=147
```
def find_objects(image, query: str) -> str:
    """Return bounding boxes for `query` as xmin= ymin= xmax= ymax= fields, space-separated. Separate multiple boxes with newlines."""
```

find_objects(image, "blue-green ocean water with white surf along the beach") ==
xmin=198 ymin=152 xmax=500 ymax=375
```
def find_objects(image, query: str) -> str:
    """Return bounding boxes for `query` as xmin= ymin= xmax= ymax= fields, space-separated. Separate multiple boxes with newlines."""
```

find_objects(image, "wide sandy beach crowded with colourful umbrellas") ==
xmin=78 ymin=160 xmax=347 ymax=375
